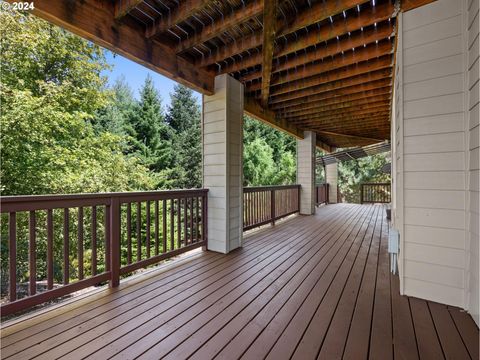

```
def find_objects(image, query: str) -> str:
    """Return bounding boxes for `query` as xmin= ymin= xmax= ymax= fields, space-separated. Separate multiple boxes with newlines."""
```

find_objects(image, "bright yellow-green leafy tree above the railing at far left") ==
xmin=0 ymin=12 xmax=152 ymax=195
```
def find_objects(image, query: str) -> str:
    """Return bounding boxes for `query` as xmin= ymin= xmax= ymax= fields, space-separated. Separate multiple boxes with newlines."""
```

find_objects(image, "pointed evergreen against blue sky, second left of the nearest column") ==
xmin=129 ymin=75 xmax=172 ymax=173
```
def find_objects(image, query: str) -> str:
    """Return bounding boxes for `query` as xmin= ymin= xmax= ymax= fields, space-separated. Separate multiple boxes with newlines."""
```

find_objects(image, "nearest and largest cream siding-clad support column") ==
xmin=202 ymin=74 xmax=243 ymax=254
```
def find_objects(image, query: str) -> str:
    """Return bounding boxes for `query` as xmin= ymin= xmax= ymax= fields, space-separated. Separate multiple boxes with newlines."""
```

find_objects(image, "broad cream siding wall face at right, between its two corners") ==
xmin=395 ymin=0 xmax=467 ymax=306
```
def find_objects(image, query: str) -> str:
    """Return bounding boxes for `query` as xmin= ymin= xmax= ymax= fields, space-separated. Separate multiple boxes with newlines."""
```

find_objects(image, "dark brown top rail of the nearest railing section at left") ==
xmin=0 ymin=189 xmax=208 ymax=213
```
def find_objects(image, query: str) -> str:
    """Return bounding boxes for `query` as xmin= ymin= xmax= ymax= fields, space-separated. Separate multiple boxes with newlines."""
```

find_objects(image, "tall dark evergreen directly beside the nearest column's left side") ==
xmin=167 ymin=84 xmax=202 ymax=189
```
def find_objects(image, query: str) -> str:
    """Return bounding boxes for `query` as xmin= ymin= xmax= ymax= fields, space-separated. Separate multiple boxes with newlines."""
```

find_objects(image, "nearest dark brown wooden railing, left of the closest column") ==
xmin=1 ymin=189 xmax=208 ymax=316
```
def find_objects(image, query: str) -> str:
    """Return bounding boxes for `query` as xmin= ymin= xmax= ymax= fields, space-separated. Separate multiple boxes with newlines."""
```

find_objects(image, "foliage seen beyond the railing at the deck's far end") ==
xmin=338 ymin=154 xmax=390 ymax=203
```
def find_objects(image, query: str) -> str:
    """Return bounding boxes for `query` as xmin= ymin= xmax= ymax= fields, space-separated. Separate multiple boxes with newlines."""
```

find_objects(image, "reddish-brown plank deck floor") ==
xmin=1 ymin=204 xmax=478 ymax=360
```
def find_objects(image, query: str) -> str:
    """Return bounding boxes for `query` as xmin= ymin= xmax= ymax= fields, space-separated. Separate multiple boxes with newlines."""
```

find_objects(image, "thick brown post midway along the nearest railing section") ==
xmin=110 ymin=197 xmax=121 ymax=287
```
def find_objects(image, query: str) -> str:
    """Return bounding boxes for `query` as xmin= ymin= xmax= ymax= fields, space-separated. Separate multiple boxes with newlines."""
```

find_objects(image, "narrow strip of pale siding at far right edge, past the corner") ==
xmin=465 ymin=0 xmax=480 ymax=325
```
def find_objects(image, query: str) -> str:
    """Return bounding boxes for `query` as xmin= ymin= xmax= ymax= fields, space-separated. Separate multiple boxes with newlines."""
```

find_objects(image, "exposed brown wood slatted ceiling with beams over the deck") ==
xmin=29 ymin=0 xmax=432 ymax=151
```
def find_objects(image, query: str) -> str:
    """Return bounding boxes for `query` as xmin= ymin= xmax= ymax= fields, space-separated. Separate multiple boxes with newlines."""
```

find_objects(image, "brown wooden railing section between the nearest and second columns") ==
xmin=243 ymin=185 xmax=300 ymax=231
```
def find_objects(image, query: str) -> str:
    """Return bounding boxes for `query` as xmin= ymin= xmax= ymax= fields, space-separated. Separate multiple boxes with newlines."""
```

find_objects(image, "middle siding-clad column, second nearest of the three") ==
xmin=297 ymin=131 xmax=316 ymax=215
